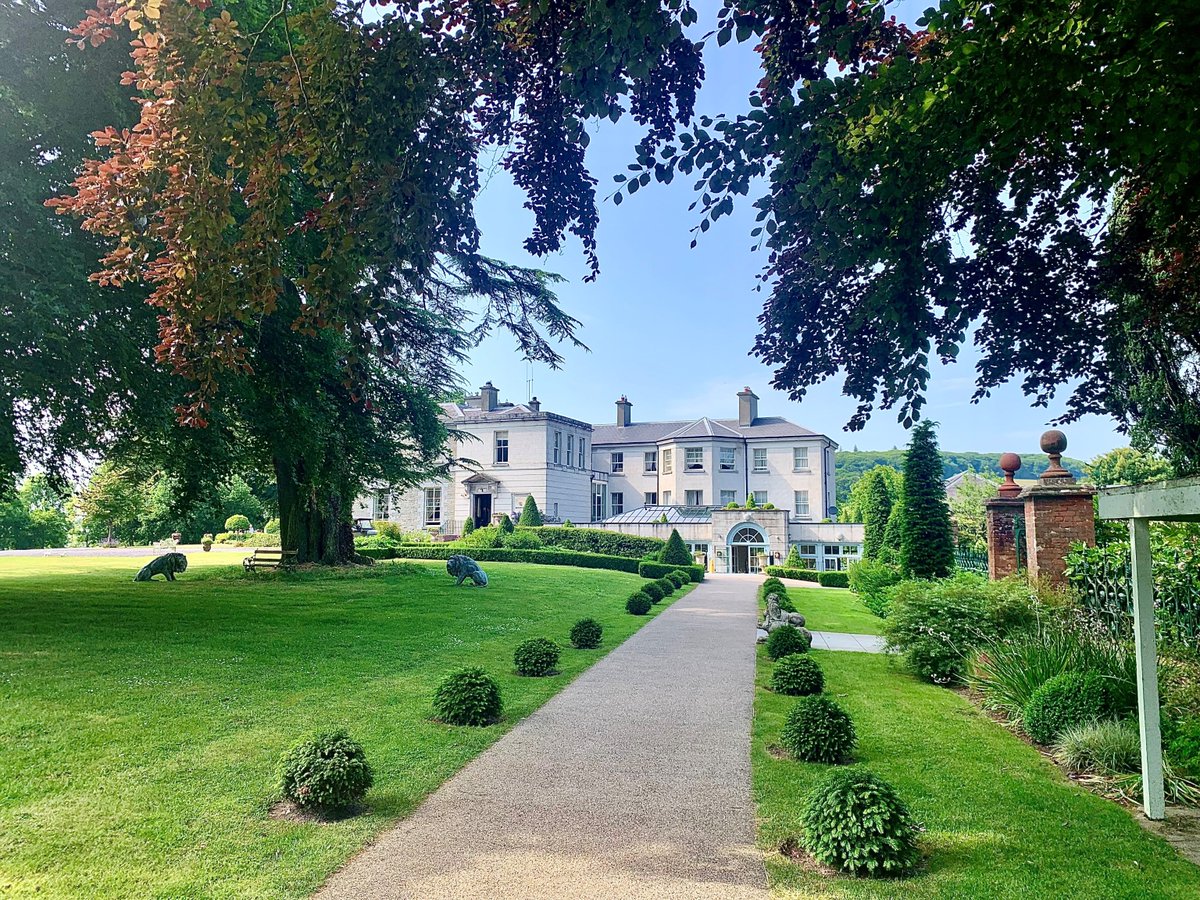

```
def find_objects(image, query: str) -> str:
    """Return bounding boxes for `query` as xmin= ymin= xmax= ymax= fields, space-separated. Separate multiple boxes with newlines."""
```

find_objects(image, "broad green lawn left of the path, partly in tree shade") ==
xmin=0 ymin=553 xmax=680 ymax=899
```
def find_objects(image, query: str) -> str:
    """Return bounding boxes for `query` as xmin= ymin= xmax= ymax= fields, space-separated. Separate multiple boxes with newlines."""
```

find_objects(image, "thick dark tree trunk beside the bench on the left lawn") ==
xmin=275 ymin=457 xmax=354 ymax=565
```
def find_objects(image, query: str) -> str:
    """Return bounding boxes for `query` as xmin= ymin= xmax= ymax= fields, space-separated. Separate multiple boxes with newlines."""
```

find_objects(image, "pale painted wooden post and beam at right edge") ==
xmin=1099 ymin=478 xmax=1200 ymax=818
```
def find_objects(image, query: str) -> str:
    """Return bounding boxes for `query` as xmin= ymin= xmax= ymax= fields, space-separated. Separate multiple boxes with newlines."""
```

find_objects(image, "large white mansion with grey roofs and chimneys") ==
xmin=354 ymin=382 xmax=863 ymax=571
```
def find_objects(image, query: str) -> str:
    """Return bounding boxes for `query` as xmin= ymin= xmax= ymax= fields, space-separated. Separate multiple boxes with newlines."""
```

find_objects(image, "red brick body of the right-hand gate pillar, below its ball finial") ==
xmin=1021 ymin=482 xmax=1096 ymax=584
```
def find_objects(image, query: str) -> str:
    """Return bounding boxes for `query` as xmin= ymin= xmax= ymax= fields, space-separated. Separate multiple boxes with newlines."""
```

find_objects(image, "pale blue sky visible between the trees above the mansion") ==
xmin=463 ymin=2 xmax=1127 ymax=460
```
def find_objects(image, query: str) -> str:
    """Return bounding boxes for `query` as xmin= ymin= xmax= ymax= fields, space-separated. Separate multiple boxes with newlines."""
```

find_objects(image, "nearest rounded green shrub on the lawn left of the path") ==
xmin=280 ymin=730 xmax=374 ymax=812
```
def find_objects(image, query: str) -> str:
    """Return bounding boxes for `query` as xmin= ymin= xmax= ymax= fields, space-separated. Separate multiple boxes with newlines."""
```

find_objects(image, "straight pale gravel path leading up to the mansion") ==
xmin=317 ymin=576 xmax=768 ymax=900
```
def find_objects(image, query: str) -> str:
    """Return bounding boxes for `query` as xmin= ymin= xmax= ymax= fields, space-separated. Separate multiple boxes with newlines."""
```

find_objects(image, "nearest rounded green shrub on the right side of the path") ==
xmin=800 ymin=766 xmax=920 ymax=877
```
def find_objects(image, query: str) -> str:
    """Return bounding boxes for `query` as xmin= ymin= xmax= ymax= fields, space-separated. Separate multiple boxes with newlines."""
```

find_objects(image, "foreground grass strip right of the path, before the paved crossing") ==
xmin=752 ymin=649 xmax=1200 ymax=900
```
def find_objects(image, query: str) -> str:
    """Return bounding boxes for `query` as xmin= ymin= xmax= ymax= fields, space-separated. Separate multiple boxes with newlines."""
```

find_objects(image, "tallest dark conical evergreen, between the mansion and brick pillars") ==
xmin=900 ymin=421 xmax=954 ymax=578
